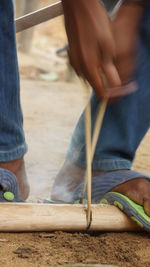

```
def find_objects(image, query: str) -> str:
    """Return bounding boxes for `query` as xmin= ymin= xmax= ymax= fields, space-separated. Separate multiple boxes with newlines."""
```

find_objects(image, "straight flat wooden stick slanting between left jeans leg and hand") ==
xmin=15 ymin=1 xmax=63 ymax=32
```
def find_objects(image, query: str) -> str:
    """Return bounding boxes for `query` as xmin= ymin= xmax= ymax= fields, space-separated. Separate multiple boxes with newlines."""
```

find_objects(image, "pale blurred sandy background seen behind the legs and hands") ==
xmin=15 ymin=0 xmax=150 ymax=201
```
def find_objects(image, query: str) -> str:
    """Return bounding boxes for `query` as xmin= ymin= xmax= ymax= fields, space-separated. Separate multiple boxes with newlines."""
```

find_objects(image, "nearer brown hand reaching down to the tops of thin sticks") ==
xmin=62 ymin=0 xmax=124 ymax=98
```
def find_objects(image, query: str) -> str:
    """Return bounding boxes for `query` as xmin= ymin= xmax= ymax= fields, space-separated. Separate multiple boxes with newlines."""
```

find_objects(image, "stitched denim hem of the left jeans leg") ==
xmin=0 ymin=143 xmax=28 ymax=162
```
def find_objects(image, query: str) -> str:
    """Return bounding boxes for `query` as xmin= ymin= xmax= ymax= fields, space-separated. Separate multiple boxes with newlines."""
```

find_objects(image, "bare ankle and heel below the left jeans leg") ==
xmin=0 ymin=158 xmax=29 ymax=200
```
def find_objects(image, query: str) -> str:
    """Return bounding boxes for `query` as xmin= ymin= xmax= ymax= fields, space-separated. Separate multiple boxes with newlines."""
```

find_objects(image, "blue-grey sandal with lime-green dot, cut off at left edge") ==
xmin=0 ymin=168 xmax=19 ymax=202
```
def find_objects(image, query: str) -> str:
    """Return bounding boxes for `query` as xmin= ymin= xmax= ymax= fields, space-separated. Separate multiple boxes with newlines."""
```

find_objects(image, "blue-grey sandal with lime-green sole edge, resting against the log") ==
xmin=74 ymin=170 xmax=150 ymax=231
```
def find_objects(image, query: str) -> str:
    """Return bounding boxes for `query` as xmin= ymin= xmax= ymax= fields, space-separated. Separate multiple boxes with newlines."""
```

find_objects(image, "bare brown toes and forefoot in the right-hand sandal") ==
xmin=112 ymin=177 xmax=150 ymax=216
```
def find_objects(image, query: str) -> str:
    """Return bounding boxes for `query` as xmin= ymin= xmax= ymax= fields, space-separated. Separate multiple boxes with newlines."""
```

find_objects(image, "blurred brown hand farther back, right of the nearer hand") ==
xmin=112 ymin=3 xmax=144 ymax=83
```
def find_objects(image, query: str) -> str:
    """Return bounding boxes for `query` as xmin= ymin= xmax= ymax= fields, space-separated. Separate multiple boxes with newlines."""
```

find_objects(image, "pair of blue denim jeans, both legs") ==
xmin=0 ymin=0 xmax=150 ymax=170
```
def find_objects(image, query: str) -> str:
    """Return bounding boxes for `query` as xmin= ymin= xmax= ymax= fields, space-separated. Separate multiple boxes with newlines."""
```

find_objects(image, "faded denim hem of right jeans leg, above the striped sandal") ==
xmin=66 ymin=152 xmax=132 ymax=171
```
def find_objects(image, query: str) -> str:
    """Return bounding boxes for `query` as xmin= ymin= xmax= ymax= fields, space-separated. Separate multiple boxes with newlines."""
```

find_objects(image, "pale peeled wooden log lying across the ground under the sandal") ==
xmin=0 ymin=203 xmax=139 ymax=232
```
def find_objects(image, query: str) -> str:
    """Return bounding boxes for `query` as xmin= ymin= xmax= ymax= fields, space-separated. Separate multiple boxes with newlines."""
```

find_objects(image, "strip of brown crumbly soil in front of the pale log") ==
xmin=0 ymin=232 xmax=150 ymax=267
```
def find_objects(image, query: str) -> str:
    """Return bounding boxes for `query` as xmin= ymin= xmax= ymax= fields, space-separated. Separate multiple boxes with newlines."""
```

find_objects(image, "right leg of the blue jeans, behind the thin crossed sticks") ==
xmin=67 ymin=1 xmax=150 ymax=171
